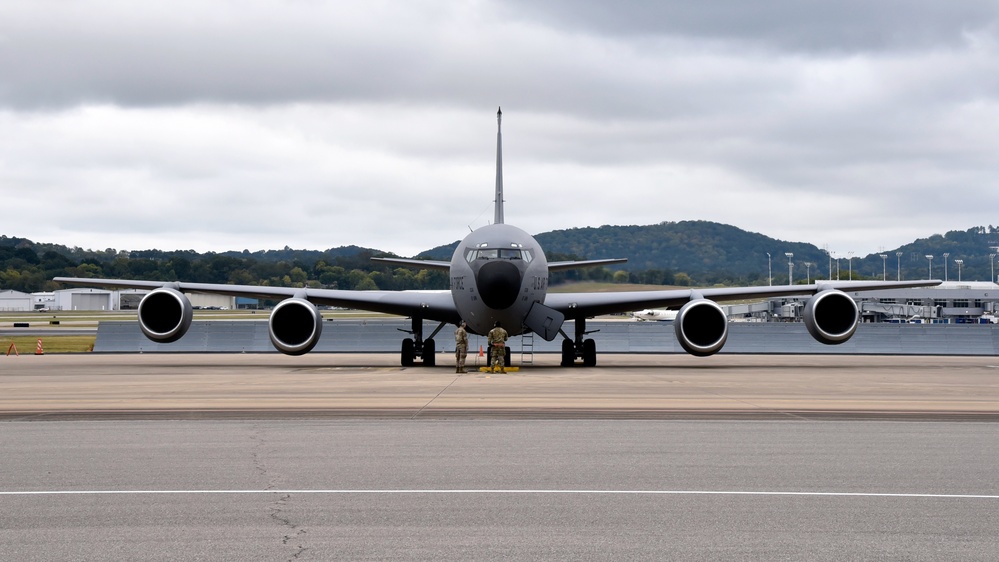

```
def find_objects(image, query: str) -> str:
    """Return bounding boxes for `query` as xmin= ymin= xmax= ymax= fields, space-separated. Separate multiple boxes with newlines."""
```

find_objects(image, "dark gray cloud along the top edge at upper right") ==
xmin=507 ymin=0 xmax=999 ymax=53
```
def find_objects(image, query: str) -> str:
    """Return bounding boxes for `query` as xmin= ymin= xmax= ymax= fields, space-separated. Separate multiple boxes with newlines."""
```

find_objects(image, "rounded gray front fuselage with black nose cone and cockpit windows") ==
xmin=450 ymin=224 xmax=548 ymax=336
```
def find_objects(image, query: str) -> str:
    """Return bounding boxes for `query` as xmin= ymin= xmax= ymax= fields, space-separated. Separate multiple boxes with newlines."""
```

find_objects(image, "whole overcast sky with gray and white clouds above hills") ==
xmin=0 ymin=0 xmax=999 ymax=256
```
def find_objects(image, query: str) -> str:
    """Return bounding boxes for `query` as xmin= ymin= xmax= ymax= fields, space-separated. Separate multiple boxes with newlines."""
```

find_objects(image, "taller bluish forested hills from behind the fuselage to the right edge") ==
xmin=420 ymin=221 xmax=999 ymax=285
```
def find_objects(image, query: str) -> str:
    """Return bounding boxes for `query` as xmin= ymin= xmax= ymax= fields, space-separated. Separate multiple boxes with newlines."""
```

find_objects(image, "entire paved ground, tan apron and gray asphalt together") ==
xmin=0 ymin=355 xmax=999 ymax=560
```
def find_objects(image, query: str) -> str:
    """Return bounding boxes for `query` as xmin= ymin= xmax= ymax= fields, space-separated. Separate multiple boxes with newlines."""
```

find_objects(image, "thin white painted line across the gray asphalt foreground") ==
xmin=0 ymin=490 xmax=999 ymax=500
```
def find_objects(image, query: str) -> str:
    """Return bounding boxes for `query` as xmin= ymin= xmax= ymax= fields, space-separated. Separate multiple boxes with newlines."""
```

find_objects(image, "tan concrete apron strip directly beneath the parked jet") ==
xmin=0 ymin=354 xmax=999 ymax=420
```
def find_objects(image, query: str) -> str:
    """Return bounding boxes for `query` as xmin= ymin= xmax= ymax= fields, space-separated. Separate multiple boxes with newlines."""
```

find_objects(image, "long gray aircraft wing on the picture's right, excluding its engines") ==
xmin=545 ymin=280 xmax=941 ymax=319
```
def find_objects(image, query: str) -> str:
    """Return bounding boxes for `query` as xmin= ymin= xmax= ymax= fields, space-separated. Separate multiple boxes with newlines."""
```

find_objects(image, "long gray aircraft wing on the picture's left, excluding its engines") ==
xmin=53 ymin=277 xmax=461 ymax=324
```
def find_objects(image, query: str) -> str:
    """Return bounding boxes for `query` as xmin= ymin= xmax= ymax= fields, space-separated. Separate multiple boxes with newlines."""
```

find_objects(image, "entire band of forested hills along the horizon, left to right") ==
xmin=0 ymin=221 xmax=999 ymax=292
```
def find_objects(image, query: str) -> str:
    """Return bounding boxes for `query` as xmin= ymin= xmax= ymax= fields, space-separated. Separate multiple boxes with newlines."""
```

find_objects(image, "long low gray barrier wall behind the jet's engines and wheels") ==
xmin=94 ymin=318 xmax=999 ymax=355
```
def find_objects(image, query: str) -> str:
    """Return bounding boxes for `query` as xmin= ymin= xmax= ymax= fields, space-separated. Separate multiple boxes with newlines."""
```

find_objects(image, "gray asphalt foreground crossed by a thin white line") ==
xmin=0 ymin=418 xmax=999 ymax=561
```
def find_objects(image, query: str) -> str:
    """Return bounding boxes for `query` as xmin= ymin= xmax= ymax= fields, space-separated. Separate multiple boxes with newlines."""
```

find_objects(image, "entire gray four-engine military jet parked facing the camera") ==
xmin=55 ymin=107 xmax=940 ymax=366
